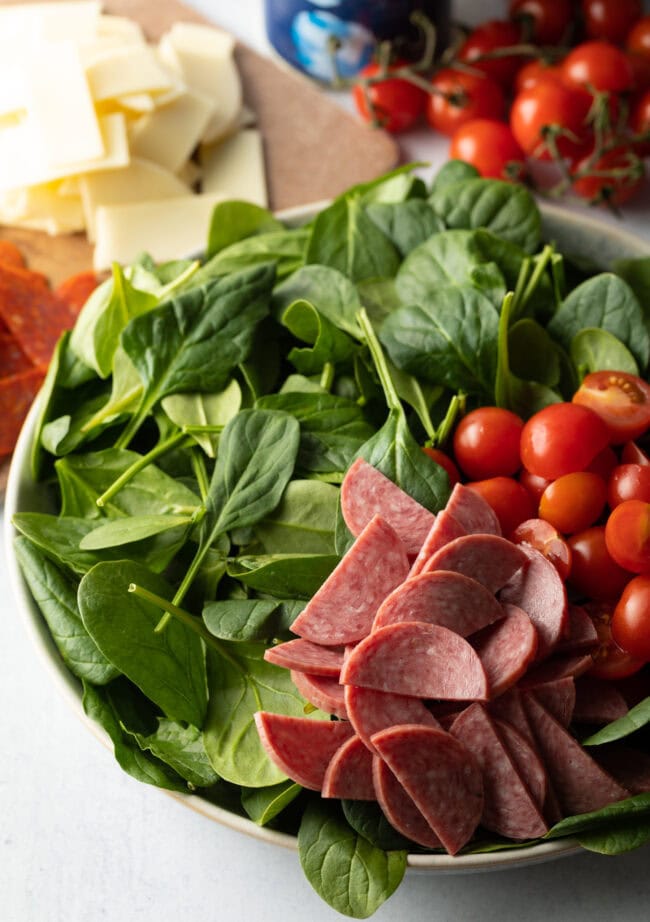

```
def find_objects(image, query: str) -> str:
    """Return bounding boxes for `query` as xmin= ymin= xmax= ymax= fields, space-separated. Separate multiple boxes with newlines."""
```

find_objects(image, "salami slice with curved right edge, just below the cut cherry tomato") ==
xmin=499 ymin=544 xmax=569 ymax=660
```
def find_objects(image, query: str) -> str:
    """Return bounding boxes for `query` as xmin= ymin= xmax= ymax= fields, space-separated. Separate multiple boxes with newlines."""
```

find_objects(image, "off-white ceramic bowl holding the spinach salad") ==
xmin=4 ymin=203 xmax=650 ymax=873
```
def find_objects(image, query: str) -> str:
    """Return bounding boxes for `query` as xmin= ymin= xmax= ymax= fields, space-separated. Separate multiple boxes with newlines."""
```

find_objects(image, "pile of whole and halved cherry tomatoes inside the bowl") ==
xmin=426 ymin=371 xmax=650 ymax=678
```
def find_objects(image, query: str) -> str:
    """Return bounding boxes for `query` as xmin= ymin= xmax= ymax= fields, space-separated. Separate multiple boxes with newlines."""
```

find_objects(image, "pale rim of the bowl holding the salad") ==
xmin=3 ymin=201 xmax=650 ymax=874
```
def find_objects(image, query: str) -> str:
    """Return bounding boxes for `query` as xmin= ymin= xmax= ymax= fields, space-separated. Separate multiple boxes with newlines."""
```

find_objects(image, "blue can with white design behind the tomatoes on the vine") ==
xmin=265 ymin=0 xmax=450 ymax=83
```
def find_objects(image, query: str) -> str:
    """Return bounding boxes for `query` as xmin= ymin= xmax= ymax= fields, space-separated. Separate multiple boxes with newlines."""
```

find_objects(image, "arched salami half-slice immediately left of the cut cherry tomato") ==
xmin=427 ymin=535 xmax=528 ymax=596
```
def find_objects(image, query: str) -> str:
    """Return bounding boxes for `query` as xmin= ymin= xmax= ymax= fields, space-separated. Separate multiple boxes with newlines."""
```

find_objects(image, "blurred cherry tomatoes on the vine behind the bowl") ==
xmin=354 ymin=0 xmax=650 ymax=205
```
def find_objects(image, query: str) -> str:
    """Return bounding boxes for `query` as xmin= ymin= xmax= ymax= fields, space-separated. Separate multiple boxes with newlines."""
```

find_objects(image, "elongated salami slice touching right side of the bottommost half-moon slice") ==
xmin=450 ymin=704 xmax=548 ymax=839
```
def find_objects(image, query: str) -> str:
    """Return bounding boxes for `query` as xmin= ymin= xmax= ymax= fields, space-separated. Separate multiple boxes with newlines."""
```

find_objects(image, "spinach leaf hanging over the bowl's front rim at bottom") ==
xmin=298 ymin=800 xmax=407 ymax=919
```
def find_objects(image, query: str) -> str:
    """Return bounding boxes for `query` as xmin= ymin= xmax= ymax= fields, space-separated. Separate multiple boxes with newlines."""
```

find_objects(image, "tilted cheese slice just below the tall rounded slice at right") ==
xmin=130 ymin=90 xmax=214 ymax=173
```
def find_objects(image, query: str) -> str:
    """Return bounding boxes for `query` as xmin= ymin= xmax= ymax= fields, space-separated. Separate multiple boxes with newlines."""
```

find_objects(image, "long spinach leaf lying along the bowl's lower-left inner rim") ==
xmin=14 ymin=535 xmax=119 ymax=685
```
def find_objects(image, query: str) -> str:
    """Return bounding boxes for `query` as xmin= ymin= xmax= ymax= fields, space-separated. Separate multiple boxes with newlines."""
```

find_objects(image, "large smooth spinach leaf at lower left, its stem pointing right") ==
xmin=79 ymin=560 xmax=207 ymax=727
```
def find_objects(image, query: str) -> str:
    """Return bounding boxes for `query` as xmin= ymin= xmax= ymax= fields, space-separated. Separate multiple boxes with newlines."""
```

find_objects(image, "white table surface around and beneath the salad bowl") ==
xmin=0 ymin=0 xmax=650 ymax=922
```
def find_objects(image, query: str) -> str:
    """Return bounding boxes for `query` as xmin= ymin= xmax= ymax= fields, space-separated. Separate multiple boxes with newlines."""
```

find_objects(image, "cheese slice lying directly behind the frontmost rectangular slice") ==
xmin=79 ymin=157 xmax=190 ymax=243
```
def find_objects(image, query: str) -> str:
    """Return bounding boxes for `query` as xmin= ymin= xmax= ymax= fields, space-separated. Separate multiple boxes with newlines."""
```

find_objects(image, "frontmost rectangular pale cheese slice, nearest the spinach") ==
xmin=93 ymin=195 xmax=224 ymax=271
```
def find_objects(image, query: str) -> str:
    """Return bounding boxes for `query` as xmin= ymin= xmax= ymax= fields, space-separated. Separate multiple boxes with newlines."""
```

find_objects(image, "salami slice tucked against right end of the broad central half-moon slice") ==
xmin=470 ymin=604 xmax=537 ymax=698
